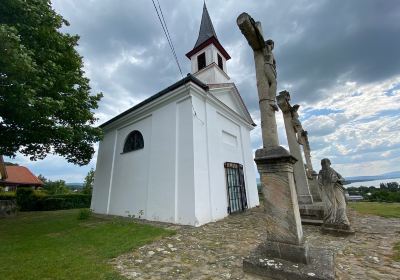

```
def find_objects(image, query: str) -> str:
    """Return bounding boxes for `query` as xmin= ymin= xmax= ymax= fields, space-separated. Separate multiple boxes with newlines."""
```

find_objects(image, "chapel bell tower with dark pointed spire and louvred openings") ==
xmin=186 ymin=3 xmax=231 ymax=84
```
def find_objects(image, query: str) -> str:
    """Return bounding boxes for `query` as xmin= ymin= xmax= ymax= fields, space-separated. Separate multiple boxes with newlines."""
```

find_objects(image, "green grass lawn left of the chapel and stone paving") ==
xmin=0 ymin=209 xmax=174 ymax=280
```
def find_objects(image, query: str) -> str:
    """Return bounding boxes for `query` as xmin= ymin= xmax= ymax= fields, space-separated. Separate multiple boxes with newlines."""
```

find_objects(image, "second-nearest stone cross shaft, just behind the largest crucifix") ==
xmin=277 ymin=91 xmax=313 ymax=204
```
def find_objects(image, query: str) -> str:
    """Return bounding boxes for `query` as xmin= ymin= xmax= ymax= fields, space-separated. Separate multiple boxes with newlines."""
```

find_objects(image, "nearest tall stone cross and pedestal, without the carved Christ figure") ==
xmin=237 ymin=13 xmax=334 ymax=280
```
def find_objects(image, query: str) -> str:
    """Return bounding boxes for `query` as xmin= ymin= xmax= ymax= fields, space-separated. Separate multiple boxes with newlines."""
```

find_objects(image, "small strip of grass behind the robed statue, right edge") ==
xmin=349 ymin=202 xmax=400 ymax=218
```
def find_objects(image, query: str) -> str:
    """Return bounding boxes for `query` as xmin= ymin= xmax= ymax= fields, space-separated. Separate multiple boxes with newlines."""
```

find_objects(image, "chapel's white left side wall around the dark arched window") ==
xmin=92 ymin=92 xmax=196 ymax=225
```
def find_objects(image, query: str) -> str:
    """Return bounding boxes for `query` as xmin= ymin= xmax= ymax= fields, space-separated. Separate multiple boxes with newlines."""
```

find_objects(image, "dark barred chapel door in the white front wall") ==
xmin=224 ymin=162 xmax=247 ymax=214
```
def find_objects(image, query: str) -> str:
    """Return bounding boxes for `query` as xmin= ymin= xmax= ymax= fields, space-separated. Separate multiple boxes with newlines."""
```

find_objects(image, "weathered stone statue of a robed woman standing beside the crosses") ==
xmin=318 ymin=158 xmax=350 ymax=231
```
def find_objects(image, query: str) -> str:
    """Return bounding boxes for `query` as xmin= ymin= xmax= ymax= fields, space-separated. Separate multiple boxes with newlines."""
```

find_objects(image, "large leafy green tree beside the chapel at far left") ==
xmin=0 ymin=0 xmax=102 ymax=165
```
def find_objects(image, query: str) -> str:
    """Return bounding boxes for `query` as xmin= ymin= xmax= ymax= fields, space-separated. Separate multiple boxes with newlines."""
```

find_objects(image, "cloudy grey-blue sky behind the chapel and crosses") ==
xmin=6 ymin=0 xmax=400 ymax=182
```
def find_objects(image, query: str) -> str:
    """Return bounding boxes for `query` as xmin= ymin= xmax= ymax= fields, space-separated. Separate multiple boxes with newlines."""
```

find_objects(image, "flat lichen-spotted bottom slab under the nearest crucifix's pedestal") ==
xmin=243 ymin=246 xmax=335 ymax=280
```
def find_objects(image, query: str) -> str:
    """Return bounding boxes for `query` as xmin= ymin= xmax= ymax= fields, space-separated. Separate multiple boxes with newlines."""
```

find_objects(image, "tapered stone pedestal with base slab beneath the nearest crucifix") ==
xmin=243 ymin=146 xmax=334 ymax=279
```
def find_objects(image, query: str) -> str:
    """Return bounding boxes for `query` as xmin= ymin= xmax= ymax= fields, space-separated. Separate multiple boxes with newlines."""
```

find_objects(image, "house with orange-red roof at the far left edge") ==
xmin=0 ymin=162 xmax=43 ymax=191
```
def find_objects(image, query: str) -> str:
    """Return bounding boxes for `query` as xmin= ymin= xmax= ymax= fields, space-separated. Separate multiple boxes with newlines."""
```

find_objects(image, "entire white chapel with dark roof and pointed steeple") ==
xmin=91 ymin=4 xmax=259 ymax=226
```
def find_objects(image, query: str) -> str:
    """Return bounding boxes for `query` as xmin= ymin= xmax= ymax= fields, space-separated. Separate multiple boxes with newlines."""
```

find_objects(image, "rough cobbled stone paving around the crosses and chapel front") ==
xmin=112 ymin=207 xmax=400 ymax=280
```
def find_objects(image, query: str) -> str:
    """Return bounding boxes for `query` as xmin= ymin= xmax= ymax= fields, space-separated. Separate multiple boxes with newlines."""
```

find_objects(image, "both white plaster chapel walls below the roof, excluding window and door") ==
xmin=92 ymin=83 xmax=258 ymax=226
